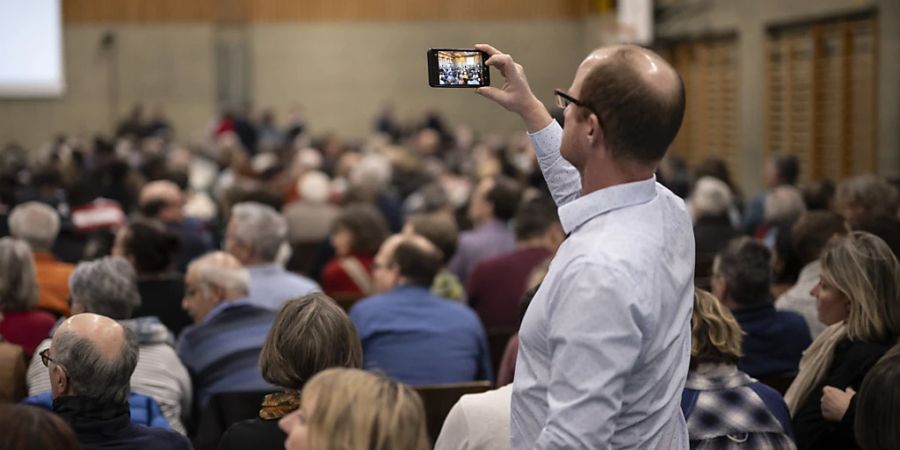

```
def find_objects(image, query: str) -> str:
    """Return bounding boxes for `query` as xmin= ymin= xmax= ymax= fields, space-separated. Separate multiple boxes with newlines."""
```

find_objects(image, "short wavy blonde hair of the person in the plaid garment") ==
xmin=691 ymin=289 xmax=744 ymax=369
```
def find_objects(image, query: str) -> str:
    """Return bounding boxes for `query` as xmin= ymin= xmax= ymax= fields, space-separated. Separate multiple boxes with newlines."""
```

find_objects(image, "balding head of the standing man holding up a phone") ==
xmin=573 ymin=45 xmax=685 ymax=164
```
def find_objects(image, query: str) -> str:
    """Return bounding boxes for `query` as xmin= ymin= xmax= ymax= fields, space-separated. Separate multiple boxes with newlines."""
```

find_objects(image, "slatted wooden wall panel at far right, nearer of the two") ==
xmin=766 ymin=14 xmax=878 ymax=181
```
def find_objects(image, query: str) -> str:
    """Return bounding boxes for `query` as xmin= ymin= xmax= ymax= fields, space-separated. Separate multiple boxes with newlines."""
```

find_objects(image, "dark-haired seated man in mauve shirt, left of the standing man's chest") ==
xmin=449 ymin=176 xmax=522 ymax=282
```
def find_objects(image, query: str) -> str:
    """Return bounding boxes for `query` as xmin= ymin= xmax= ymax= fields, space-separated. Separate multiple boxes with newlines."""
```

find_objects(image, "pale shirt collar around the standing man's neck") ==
xmin=559 ymin=175 xmax=656 ymax=234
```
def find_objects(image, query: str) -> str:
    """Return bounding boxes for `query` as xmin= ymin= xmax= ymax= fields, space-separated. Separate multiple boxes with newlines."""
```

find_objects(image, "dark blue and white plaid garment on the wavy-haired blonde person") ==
xmin=682 ymin=365 xmax=797 ymax=450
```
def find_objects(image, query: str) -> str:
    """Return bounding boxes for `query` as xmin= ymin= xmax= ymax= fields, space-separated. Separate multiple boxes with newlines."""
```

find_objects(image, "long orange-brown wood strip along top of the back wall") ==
xmin=63 ymin=0 xmax=597 ymax=23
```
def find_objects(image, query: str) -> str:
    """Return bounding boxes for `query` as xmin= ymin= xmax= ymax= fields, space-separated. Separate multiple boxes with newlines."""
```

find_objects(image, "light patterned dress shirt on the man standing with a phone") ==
xmin=510 ymin=121 xmax=694 ymax=450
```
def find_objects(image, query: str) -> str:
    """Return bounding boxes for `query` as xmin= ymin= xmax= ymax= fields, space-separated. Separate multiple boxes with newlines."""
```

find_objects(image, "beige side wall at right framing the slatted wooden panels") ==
xmin=656 ymin=0 xmax=900 ymax=192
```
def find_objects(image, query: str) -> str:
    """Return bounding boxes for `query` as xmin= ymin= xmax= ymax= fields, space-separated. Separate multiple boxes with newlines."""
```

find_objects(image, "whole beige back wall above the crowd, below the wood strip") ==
xmin=0 ymin=19 xmax=598 ymax=146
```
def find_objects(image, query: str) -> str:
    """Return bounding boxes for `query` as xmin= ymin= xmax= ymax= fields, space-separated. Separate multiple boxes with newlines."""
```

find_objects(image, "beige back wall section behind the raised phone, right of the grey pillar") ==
xmin=251 ymin=21 xmax=585 ymax=137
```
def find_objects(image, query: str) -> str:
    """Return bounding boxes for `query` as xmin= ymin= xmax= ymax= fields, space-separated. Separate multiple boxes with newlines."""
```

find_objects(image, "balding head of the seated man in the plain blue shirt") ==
xmin=374 ymin=234 xmax=442 ymax=292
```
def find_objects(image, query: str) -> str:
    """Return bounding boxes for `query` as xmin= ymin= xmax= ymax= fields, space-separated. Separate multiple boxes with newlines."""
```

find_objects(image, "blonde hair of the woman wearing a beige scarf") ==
xmin=822 ymin=231 xmax=900 ymax=343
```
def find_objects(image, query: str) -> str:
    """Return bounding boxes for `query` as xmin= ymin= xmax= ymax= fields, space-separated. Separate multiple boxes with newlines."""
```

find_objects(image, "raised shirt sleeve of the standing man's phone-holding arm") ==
xmin=528 ymin=120 xmax=581 ymax=206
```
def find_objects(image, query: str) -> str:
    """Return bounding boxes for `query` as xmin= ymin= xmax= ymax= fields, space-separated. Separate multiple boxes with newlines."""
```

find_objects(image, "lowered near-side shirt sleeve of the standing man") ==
xmin=534 ymin=263 xmax=643 ymax=449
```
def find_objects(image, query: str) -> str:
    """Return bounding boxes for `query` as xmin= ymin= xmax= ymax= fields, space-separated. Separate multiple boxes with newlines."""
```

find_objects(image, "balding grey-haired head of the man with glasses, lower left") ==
xmin=49 ymin=313 xmax=138 ymax=404
